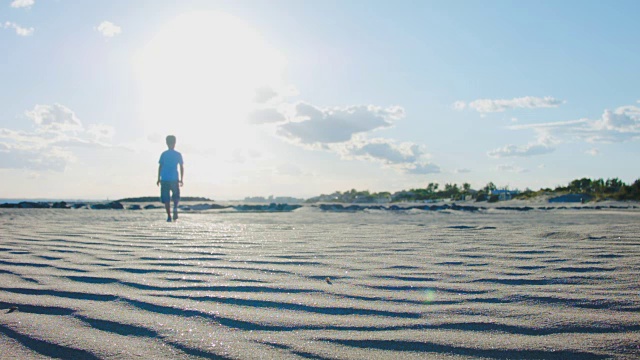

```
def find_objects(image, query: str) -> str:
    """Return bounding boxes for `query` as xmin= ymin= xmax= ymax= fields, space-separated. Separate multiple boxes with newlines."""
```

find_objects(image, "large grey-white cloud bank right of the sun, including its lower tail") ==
xmin=248 ymin=96 xmax=440 ymax=174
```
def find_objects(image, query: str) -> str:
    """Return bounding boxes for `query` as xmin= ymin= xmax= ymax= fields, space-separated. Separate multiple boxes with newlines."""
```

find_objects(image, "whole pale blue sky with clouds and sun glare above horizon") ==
xmin=0 ymin=0 xmax=640 ymax=200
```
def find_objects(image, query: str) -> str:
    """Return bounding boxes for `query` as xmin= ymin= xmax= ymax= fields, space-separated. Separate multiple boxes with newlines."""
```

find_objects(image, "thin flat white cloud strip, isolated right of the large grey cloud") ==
xmin=454 ymin=96 xmax=565 ymax=113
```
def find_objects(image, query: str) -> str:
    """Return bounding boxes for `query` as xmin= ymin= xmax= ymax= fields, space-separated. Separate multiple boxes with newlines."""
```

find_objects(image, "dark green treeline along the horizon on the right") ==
xmin=306 ymin=178 xmax=640 ymax=203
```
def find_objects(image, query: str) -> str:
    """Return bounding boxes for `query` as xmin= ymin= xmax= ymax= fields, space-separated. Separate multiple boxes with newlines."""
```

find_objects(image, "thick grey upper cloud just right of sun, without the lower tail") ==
xmin=278 ymin=103 xmax=404 ymax=145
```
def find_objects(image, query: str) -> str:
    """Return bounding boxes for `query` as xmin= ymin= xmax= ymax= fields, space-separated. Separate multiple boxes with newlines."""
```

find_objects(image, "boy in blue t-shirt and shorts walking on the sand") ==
xmin=156 ymin=135 xmax=184 ymax=222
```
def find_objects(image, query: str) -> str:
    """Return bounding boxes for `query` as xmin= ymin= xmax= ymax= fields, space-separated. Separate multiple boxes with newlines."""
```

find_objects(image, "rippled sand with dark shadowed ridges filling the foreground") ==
xmin=0 ymin=208 xmax=640 ymax=359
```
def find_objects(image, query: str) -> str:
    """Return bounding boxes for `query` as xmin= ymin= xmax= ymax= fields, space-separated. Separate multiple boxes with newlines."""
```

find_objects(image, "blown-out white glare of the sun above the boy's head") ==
xmin=135 ymin=11 xmax=284 ymax=149
